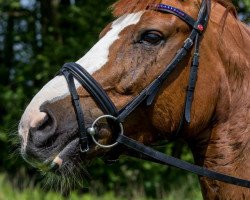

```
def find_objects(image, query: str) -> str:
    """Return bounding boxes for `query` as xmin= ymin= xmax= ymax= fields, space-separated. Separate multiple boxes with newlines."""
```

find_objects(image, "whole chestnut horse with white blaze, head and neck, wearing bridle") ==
xmin=18 ymin=0 xmax=250 ymax=199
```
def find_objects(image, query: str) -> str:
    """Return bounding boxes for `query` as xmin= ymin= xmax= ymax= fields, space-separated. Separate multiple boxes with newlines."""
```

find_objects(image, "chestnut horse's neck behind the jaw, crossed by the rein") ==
xmin=192 ymin=1 xmax=250 ymax=199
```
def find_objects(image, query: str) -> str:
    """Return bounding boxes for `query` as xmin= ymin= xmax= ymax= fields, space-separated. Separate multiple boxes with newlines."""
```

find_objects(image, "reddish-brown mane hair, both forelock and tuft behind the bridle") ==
xmin=111 ymin=0 xmax=237 ymax=17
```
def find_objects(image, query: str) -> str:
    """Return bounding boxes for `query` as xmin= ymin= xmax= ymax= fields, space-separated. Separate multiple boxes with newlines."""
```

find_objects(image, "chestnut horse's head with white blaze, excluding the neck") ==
xmin=19 ymin=0 xmax=249 ymax=198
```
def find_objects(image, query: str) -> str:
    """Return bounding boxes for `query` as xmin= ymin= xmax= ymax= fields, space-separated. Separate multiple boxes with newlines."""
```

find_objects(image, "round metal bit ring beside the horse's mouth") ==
xmin=88 ymin=115 xmax=123 ymax=148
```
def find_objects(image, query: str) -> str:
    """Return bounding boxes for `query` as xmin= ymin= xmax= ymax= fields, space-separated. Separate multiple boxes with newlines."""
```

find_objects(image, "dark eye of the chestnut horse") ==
xmin=139 ymin=31 xmax=163 ymax=46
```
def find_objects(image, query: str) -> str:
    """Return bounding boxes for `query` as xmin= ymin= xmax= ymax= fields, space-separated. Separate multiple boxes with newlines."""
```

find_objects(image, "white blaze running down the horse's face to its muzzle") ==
xmin=19 ymin=12 xmax=144 ymax=147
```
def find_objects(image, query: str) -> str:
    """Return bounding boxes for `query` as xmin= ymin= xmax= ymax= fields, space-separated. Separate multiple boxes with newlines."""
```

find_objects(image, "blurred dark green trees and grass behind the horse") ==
xmin=0 ymin=0 xmax=250 ymax=200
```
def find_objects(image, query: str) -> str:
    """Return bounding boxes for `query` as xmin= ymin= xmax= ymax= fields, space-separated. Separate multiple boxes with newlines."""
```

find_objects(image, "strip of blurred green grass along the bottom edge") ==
xmin=0 ymin=174 xmax=202 ymax=200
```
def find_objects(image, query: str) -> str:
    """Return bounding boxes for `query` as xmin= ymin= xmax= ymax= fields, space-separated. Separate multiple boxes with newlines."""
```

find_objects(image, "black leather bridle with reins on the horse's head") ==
xmin=60 ymin=0 xmax=250 ymax=188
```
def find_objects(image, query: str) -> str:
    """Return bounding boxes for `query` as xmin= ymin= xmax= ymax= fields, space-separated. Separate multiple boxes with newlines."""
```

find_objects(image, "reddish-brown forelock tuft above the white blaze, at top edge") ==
xmin=111 ymin=0 xmax=161 ymax=17
